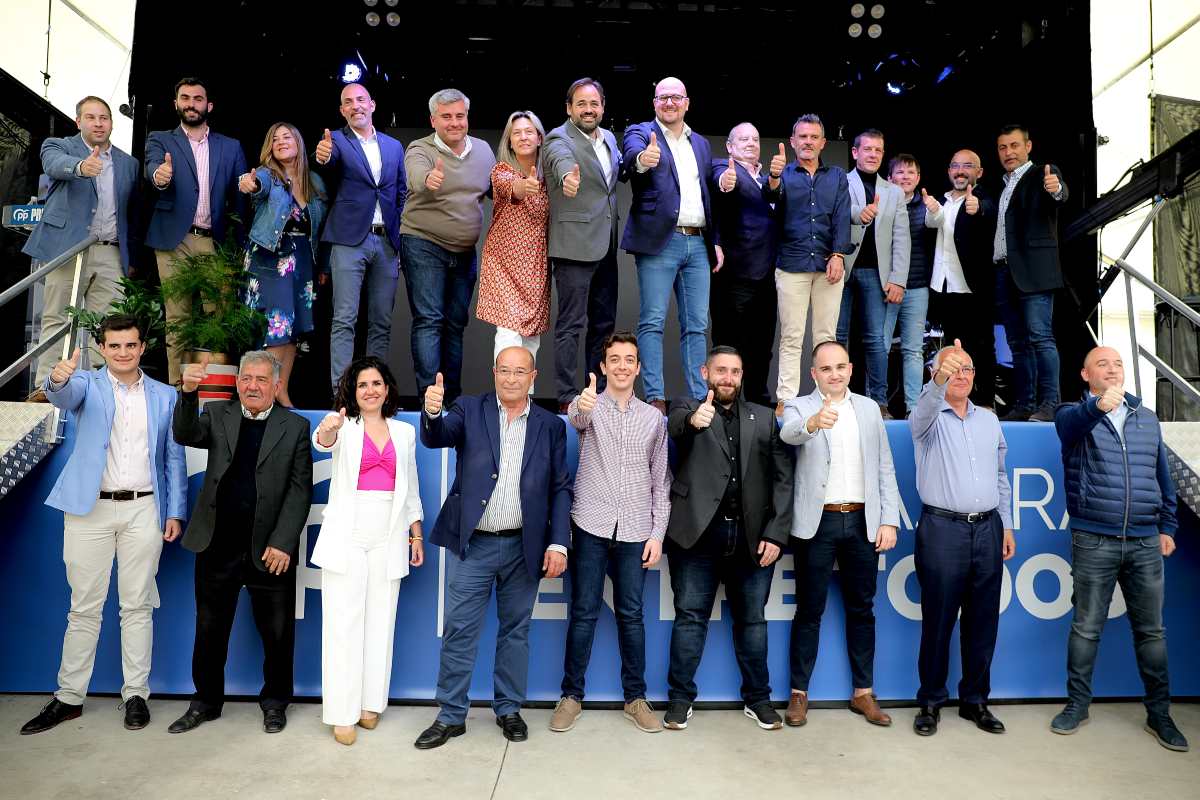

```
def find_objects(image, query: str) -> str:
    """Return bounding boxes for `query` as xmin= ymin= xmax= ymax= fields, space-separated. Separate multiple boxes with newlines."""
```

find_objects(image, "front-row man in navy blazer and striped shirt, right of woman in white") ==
xmin=414 ymin=347 xmax=571 ymax=750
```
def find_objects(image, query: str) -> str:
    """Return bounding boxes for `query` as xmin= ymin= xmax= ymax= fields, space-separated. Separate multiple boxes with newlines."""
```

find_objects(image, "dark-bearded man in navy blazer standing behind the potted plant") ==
xmin=146 ymin=78 xmax=246 ymax=384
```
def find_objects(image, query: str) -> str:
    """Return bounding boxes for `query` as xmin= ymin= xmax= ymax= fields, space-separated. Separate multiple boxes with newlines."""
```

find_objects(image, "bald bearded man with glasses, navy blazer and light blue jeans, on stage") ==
xmin=620 ymin=78 xmax=716 ymax=414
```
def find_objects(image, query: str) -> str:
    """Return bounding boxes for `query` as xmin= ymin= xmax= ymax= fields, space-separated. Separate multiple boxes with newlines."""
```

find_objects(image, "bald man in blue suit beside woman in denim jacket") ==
xmin=317 ymin=83 xmax=408 ymax=387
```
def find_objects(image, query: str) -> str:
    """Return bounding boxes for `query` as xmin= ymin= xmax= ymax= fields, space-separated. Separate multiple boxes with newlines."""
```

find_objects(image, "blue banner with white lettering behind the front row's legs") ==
xmin=0 ymin=413 xmax=1200 ymax=700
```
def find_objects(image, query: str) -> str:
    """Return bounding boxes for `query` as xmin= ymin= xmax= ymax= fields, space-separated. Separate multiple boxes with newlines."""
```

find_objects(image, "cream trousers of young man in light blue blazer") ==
xmin=54 ymin=495 xmax=162 ymax=705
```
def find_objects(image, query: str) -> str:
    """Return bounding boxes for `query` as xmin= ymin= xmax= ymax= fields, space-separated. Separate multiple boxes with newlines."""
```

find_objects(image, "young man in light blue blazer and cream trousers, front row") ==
xmin=20 ymin=314 xmax=187 ymax=734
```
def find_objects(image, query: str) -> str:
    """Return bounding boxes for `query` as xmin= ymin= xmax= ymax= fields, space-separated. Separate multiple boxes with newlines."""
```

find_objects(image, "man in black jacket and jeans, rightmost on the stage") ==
xmin=992 ymin=125 xmax=1068 ymax=422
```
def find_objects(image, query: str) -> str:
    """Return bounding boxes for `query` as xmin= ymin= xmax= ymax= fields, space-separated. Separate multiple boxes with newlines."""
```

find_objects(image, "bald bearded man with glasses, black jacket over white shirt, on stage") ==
xmin=929 ymin=150 xmax=996 ymax=408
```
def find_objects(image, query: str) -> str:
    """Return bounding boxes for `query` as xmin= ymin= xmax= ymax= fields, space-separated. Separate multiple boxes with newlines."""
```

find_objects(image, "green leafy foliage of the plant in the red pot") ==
xmin=162 ymin=243 xmax=266 ymax=356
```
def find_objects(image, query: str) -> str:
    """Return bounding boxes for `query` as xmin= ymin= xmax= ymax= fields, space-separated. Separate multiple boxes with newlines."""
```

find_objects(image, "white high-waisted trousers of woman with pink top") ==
xmin=320 ymin=492 xmax=400 ymax=726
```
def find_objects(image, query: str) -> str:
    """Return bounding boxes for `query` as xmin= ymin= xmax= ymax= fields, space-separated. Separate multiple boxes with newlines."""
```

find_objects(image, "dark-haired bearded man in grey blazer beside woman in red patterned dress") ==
xmin=541 ymin=78 xmax=628 ymax=414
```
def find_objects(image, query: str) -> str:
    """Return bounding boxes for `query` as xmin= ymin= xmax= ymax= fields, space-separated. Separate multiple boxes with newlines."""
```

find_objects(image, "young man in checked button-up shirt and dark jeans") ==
xmin=550 ymin=333 xmax=671 ymax=733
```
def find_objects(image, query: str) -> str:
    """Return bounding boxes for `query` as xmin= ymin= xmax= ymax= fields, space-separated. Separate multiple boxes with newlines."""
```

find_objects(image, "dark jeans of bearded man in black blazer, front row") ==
xmin=666 ymin=515 xmax=775 ymax=706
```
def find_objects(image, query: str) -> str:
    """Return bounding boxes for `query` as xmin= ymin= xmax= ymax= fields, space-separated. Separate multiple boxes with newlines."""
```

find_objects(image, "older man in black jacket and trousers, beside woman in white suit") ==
xmin=167 ymin=350 xmax=312 ymax=733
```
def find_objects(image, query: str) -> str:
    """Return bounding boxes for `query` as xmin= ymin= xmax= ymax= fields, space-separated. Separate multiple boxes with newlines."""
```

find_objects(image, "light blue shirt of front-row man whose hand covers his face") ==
xmin=910 ymin=380 xmax=1013 ymax=529
